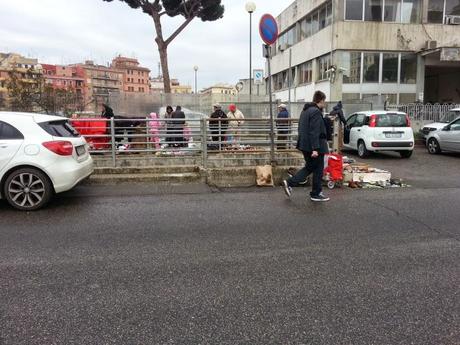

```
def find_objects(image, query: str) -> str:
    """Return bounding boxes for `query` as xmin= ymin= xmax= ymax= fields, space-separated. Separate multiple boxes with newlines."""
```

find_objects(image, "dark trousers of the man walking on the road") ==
xmin=287 ymin=151 xmax=324 ymax=196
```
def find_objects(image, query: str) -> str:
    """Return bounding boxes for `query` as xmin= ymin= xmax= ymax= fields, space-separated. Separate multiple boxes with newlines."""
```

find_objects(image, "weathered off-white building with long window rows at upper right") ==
xmin=271 ymin=0 xmax=460 ymax=104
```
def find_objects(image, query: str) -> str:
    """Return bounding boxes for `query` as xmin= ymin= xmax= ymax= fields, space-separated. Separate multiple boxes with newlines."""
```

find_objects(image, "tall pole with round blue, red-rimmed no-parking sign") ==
xmin=259 ymin=14 xmax=279 ymax=164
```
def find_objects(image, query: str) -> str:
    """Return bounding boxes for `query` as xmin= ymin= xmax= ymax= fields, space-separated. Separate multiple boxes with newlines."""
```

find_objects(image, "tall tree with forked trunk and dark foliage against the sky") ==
xmin=103 ymin=0 xmax=224 ymax=93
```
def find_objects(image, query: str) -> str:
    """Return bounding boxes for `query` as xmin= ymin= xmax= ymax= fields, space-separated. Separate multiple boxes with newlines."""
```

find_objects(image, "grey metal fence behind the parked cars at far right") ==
xmin=387 ymin=103 xmax=460 ymax=122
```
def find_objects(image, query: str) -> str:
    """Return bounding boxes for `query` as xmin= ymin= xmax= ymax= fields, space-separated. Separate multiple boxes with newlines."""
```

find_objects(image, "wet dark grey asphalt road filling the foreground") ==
xmin=0 ymin=146 xmax=460 ymax=345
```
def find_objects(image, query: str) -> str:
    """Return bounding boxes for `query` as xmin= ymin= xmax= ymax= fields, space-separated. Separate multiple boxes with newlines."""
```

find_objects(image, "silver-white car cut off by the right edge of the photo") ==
xmin=426 ymin=117 xmax=460 ymax=154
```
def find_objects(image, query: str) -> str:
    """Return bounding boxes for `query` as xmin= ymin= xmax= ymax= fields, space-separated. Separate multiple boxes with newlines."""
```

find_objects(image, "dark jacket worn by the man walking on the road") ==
xmin=297 ymin=103 xmax=329 ymax=154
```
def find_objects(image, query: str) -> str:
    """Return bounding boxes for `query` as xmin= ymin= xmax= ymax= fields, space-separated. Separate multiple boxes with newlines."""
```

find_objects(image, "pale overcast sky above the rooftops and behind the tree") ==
xmin=0 ymin=0 xmax=293 ymax=89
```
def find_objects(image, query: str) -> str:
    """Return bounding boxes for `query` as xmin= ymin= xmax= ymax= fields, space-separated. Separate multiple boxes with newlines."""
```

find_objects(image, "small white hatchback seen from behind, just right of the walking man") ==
xmin=343 ymin=110 xmax=415 ymax=158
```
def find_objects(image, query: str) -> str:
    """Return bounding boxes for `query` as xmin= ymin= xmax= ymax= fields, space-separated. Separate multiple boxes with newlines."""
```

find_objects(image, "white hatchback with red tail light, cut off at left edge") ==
xmin=0 ymin=112 xmax=93 ymax=211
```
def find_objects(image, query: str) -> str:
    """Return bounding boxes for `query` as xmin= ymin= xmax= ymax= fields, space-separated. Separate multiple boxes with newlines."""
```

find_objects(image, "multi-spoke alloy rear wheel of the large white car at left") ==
xmin=3 ymin=168 xmax=53 ymax=211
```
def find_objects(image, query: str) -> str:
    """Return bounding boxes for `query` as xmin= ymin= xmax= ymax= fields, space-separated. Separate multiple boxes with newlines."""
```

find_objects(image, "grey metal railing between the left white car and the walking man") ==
xmin=71 ymin=118 xmax=298 ymax=167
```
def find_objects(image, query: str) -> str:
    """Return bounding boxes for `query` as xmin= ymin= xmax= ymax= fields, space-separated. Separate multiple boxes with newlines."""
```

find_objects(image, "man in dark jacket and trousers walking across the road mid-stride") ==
xmin=283 ymin=91 xmax=329 ymax=202
